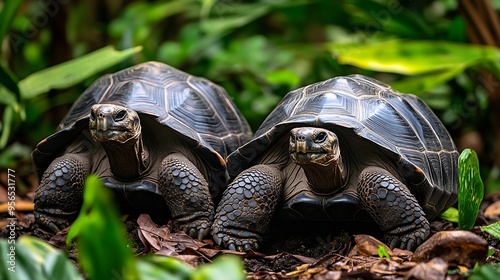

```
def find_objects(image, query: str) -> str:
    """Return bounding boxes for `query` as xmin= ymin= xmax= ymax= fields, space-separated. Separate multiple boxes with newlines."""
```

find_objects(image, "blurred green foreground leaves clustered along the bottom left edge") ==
xmin=0 ymin=175 xmax=245 ymax=280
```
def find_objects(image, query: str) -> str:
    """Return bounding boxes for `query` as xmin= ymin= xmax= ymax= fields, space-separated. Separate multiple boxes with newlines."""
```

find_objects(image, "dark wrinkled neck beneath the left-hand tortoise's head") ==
xmin=101 ymin=134 xmax=149 ymax=180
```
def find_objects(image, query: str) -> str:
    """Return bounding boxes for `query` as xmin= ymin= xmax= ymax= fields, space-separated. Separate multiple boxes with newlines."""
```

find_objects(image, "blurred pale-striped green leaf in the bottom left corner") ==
xmin=0 ymin=235 xmax=83 ymax=280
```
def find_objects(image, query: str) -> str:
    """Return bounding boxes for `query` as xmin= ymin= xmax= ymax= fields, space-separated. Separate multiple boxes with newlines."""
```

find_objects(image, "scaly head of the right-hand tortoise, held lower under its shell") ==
xmin=289 ymin=127 xmax=340 ymax=166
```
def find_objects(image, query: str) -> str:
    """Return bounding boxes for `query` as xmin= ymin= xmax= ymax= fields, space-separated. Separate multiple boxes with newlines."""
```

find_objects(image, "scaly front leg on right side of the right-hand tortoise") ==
xmin=358 ymin=167 xmax=430 ymax=250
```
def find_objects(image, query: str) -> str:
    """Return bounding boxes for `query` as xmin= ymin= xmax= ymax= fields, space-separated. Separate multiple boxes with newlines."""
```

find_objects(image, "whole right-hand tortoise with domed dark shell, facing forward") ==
xmin=211 ymin=75 xmax=458 ymax=250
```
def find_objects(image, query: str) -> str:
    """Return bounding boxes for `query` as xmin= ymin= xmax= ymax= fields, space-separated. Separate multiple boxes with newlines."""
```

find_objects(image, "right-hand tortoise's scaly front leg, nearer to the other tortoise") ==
xmin=212 ymin=165 xmax=283 ymax=251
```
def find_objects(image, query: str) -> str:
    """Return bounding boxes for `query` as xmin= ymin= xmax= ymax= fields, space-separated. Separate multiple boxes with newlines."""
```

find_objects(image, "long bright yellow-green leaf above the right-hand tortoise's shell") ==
xmin=327 ymin=40 xmax=500 ymax=75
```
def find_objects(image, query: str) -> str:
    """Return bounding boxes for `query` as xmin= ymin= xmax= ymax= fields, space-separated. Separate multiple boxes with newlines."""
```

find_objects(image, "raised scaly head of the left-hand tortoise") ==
xmin=89 ymin=104 xmax=141 ymax=143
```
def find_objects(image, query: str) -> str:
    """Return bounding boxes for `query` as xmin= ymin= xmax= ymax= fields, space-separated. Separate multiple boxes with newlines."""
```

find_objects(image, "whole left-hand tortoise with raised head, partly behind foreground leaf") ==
xmin=32 ymin=62 xmax=252 ymax=239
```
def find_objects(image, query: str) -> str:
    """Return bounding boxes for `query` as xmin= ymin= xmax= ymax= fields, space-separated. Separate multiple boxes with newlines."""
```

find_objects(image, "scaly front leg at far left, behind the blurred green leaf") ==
xmin=34 ymin=154 xmax=89 ymax=233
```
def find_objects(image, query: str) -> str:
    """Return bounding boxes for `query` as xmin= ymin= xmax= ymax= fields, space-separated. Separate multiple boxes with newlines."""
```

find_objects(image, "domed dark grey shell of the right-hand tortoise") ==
xmin=227 ymin=75 xmax=458 ymax=218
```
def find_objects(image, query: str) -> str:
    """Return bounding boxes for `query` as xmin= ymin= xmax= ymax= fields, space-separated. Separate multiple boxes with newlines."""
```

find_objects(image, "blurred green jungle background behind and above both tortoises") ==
xmin=0 ymin=0 xmax=500 ymax=195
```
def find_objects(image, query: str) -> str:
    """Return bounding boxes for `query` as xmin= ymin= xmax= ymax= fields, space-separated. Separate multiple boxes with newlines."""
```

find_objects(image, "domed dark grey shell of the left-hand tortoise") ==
xmin=32 ymin=62 xmax=252 ymax=192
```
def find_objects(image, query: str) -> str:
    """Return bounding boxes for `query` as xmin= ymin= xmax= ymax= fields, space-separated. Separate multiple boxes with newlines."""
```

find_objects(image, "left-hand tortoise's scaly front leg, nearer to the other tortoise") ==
xmin=158 ymin=153 xmax=214 ymax=240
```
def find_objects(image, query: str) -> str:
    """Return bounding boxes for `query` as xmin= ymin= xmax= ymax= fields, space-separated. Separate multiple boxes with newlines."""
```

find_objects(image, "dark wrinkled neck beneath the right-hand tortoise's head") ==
xmin=301 ymin=154 xmax=347 ymax=195
